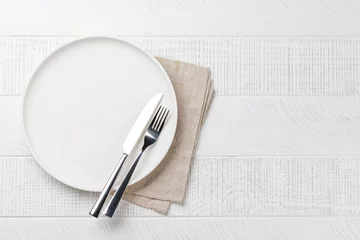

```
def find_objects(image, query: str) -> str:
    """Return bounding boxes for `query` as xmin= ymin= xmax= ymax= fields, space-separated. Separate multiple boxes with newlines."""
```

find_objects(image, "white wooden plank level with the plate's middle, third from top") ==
xmin=0 ymin=96 xmax=360 ymax=156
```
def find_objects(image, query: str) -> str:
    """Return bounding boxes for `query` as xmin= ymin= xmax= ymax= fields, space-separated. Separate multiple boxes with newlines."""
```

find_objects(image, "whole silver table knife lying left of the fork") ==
xmin=89 ymin=93 xmax=164 ymax=218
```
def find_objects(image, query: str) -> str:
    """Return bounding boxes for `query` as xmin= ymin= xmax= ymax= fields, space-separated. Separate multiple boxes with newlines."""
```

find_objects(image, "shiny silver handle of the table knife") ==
xmin=89 ymin=153 xmax=128 ymax=218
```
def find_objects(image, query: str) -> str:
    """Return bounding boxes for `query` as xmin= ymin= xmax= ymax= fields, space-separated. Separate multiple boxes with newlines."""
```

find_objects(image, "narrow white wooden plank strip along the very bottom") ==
xmin=0 ymin=217 xmax=360 ymax=240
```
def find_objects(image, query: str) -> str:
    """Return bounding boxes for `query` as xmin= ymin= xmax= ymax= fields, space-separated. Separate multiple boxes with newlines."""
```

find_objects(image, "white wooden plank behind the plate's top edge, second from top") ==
xmin=0 ymin=37 xmax=360 ymax=96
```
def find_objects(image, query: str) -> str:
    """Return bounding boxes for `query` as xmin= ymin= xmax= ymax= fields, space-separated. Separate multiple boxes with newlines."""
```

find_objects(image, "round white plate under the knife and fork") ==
xmin=23 ymin=37 xmax=177 ymax=191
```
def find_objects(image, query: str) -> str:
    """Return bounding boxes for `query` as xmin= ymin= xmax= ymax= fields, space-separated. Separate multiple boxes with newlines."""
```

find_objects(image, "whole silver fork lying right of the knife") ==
xmin=103 ymin=106 xmax=170 ymax=218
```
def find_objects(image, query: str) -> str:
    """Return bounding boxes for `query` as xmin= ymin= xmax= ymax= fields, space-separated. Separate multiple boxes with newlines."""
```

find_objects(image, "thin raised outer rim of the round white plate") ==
xmin=21 ymin=35 xmax=178 ymax=192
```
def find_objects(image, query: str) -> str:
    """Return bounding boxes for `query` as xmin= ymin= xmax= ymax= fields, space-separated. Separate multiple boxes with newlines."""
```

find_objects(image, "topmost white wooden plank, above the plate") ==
xmin=0 ymin=0 xmax=360 ymax=36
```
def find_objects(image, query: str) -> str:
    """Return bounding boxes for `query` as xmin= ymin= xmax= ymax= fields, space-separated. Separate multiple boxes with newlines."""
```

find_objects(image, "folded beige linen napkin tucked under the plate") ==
xmin=124 ymin=58 xmax=214 ymax=214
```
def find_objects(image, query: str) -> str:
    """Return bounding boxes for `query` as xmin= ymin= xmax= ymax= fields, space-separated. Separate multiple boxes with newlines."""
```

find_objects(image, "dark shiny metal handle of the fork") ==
xmin=103 ymin=149 xmax=145 ymax=218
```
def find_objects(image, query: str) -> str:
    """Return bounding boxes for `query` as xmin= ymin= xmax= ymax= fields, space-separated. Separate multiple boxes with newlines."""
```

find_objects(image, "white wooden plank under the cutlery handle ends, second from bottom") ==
xmin=0 ymin=157 xmax=360 ymax=218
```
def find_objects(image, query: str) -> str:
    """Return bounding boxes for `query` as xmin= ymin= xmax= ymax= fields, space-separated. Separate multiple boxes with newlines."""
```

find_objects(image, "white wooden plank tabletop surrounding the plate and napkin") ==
xmin=0 ymin=0 xmax=360 ymax=239
